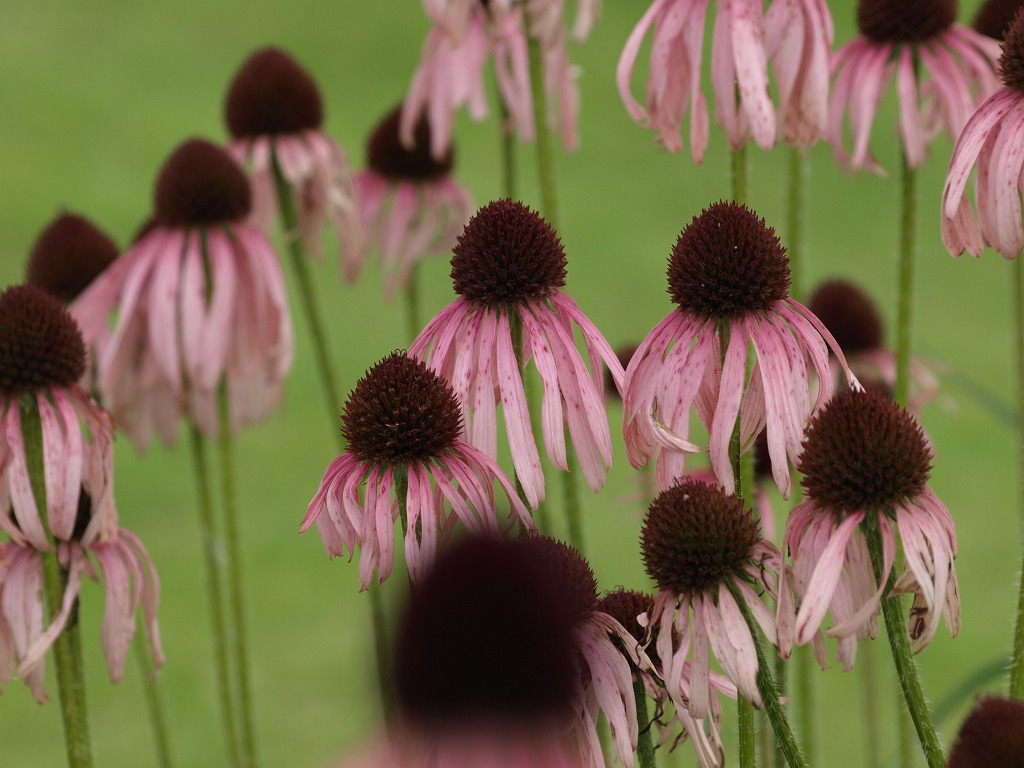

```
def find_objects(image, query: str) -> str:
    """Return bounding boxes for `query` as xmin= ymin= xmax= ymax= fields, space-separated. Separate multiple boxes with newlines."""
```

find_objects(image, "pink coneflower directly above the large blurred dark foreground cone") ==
xmin=301 ymin=352 xmax=534 ymax=589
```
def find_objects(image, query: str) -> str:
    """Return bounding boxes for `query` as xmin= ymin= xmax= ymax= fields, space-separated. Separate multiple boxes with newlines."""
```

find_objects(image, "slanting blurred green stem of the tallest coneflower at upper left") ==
xmin=273 ymin=157 xmax=345 ymax=452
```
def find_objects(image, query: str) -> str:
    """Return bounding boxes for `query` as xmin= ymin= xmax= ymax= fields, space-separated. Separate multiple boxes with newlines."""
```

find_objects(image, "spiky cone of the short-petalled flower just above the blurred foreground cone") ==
xmin=341 ymin=352 xmax=462 ymax=464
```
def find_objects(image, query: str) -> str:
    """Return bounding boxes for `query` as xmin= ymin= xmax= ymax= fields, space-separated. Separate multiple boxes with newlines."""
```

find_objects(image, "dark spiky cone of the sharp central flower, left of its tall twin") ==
xmin=452 ymin=199 xmax=565 ymax=304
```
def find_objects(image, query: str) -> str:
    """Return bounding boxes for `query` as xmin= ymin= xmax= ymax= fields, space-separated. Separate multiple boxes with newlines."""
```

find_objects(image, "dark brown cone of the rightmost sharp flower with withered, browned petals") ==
xmin=800 ymin=391 xmax=932 ymax=513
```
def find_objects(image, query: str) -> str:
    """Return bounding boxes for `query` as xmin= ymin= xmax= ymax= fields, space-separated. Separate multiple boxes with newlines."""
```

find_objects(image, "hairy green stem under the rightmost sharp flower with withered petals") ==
xmin=863 ymin=511 xmax=946 ymax=768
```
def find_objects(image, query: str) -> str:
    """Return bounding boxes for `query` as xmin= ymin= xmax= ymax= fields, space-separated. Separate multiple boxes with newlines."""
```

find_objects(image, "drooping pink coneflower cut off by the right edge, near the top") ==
xmin=942 ymin=13 xmax=1024 ymax=258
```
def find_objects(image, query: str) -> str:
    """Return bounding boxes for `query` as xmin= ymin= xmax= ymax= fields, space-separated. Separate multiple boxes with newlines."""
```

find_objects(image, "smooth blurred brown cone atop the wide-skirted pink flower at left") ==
xmin=155 ymin=138 xmax=252 ymax=226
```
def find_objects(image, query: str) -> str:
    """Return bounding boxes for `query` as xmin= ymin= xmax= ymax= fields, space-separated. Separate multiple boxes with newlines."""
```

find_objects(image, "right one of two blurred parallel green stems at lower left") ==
xmin=217 ymin=385 xmax=257 ymax=766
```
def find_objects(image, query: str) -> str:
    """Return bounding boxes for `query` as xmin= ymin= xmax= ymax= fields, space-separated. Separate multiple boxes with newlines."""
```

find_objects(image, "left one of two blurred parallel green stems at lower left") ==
xmin=188 ymin=424 xmax=243 ymax=768
